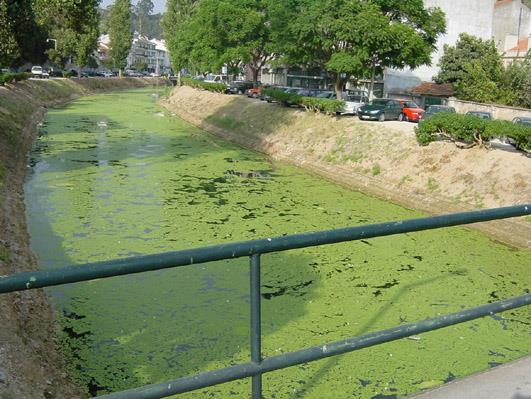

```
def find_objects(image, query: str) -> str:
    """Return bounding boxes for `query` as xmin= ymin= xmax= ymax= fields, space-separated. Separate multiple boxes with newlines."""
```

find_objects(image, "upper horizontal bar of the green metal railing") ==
xmin=0 ymin=204 xmax=531 ymax=293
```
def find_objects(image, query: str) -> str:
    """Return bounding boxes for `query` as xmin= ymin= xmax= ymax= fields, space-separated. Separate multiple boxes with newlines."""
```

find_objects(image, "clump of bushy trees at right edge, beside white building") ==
xmin=435 ymin=33 xmax=531 ymax=108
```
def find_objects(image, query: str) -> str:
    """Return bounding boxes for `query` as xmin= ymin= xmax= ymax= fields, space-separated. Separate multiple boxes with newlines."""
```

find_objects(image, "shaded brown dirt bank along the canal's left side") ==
xmin=0 ymin=78 xmax=164 ymax=399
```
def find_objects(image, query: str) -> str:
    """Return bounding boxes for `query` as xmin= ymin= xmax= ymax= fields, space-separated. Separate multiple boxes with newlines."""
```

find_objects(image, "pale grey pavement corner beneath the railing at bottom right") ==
xmin=408 ymin=357 xmax=531 ymax=399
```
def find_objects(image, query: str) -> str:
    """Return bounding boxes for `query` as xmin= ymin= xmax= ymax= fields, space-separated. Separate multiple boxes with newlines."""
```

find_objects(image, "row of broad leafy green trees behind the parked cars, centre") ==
xmin=163 ymin=0 xmax=445 ymax=96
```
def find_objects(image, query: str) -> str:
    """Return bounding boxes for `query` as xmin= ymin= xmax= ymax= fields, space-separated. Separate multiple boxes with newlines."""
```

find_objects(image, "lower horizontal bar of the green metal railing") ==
xmin=98 ymin=294 xmax=531 ymax=399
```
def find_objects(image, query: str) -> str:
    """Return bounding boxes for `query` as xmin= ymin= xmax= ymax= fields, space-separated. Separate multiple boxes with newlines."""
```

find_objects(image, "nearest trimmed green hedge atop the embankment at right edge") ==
xmin=415 ymin=113 xmax=531 ymax=151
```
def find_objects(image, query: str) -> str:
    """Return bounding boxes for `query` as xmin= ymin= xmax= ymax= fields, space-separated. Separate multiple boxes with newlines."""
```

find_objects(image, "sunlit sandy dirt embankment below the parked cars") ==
xmin=163 ymin=86 xmax=531 ymax=248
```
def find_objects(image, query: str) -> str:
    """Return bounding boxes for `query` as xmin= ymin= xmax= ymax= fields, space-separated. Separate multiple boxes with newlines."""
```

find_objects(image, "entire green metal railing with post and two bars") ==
xmin=0 ymin=204 xmax=531 ymax=399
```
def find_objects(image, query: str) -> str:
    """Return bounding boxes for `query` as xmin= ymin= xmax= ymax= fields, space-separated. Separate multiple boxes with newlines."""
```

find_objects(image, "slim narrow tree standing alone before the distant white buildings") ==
xmin=109 ymin=0 xmax=133 ymax=76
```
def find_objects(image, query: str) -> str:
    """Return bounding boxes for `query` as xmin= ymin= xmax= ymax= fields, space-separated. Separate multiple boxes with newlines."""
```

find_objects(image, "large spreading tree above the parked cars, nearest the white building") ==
xmin=277 ymin=0 xmax=445 ymax=98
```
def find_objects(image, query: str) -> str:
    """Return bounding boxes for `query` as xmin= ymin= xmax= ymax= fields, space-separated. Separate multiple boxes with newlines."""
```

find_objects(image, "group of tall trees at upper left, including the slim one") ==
xmin=0 ymin=0 xmax=140 ymax=77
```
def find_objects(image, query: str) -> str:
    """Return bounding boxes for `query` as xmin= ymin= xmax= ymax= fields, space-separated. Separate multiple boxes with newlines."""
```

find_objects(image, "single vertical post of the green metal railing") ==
xmin=250 ymin=254 xmax=262 ymax=399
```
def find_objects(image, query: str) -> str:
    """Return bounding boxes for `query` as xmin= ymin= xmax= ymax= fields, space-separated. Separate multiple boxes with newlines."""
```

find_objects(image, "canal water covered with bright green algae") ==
xmin=25 ymin=89 xmax=531 ymax=399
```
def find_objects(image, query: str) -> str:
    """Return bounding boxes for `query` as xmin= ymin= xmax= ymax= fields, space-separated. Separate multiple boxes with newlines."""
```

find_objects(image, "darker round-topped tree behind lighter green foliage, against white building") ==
xmin=435 ymin=33 xmax=503 ymax=84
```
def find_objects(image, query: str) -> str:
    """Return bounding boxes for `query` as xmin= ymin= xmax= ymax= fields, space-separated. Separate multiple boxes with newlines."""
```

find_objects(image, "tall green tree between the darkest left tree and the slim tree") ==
xmin=35 ymin=0 xmax=99 ymax=74
